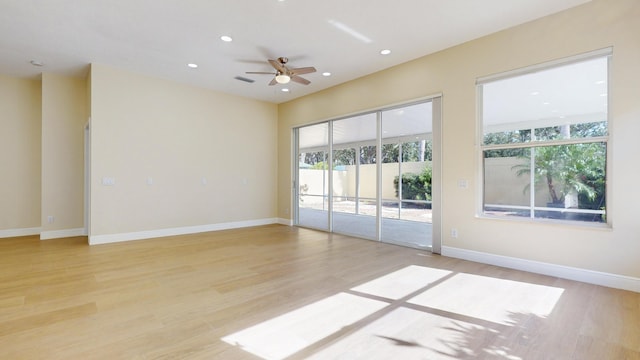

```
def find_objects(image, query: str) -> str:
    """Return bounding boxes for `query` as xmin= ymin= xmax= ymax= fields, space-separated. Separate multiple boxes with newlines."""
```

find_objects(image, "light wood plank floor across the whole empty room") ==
xmin=0 ymin=225 xmax=640 ymax=359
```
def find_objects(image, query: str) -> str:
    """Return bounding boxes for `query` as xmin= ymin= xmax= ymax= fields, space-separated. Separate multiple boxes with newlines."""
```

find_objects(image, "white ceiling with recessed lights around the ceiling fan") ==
xmin=0 ymin=0 xmax=589 ymax=103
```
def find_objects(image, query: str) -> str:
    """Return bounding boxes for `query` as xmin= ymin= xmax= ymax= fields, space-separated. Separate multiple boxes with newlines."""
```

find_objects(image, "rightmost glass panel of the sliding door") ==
xmin=381 ymin=102 xmax=433 ymax=248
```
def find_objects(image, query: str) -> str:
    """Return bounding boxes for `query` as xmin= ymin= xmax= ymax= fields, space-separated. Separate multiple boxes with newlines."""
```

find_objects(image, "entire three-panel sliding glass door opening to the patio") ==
xmin=294 ymin=98 xmax=440 ymax=248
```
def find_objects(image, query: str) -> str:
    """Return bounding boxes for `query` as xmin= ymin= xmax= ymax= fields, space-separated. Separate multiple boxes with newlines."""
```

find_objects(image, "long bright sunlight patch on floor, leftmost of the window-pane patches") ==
xmin=222 ymin=293 xmax=389 ymax=359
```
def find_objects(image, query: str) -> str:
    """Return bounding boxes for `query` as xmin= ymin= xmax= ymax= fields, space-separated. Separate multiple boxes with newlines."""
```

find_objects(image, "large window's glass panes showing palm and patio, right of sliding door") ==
xmin=478 ymin=50 xmax=610 ymax=223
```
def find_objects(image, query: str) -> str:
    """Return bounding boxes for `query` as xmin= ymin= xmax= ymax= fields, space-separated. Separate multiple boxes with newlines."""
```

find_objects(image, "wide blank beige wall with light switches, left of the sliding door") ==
xmin=90 ymin=64 xmax=278 ymax=236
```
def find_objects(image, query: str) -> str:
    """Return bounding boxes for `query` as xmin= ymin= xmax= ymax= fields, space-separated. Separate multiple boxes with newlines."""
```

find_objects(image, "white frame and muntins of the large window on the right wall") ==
xmin=476 ymin=47 xmax=613 ymax=228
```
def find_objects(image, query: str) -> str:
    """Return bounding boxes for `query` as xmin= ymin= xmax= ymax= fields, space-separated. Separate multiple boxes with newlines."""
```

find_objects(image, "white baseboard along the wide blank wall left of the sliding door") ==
xmin=89 ymin=218 xmax=278 ymax=245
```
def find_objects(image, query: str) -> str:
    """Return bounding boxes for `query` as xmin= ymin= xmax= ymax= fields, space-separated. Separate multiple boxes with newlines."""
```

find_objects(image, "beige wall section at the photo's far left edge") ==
xmin=0 ymin=75 xmax=41 ymax=233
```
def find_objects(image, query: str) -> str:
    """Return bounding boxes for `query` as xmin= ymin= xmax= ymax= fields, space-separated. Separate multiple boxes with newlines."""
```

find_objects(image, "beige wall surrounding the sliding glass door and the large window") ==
xmin=278 ymin=0 xmax=640 ymax=277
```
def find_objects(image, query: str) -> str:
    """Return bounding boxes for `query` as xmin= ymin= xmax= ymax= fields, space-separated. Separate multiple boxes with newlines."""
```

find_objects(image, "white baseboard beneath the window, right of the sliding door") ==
xmin=442 ymin=246 xmax=640 ymax=292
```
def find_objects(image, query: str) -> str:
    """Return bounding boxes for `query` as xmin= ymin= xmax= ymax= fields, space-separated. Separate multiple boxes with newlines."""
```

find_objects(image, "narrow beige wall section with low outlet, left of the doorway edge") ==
xmin=41 ymin=73 xmax=88 ymax=232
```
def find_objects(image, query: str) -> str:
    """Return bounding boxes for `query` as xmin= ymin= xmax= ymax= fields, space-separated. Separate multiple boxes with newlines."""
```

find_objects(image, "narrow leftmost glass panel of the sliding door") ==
xmin=296 ymin=123 xmax=329 ymax=230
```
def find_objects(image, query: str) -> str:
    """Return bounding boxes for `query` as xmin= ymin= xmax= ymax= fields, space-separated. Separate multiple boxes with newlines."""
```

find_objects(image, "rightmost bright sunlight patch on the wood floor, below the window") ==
xmin=408 ymin=273 xmax=564 ymax=325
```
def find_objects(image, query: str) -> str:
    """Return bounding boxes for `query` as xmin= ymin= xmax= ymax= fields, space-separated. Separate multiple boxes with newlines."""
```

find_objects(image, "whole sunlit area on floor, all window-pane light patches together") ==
xmin=222 ymin=265 xmax=564 ymax=360
